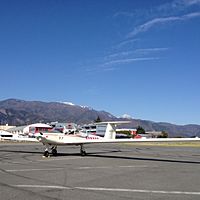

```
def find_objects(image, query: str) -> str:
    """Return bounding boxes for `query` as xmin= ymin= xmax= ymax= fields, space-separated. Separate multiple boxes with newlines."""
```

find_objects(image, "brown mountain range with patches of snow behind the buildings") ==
xmin=0 ymin=99 xmax=200 ymax=137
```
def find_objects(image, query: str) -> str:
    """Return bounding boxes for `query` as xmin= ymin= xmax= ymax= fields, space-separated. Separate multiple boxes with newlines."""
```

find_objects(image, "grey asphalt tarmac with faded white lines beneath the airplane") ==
xmin=0 ymin=142 xmax=200 ymax=200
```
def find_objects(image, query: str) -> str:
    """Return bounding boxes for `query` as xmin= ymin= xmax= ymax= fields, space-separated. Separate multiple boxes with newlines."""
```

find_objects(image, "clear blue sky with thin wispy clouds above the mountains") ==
xmin=0 ymin=0 xmax=200 ymax=124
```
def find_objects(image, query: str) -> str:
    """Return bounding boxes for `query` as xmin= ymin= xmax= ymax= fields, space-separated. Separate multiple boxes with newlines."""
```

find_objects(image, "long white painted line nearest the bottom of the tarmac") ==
xmin=12 ymin=185 xmax=200 ymax=195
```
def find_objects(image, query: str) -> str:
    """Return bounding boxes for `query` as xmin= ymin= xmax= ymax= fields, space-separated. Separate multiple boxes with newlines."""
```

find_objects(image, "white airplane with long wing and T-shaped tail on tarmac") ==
xmin=36 ymin=121 xmax=200 ymax=157
